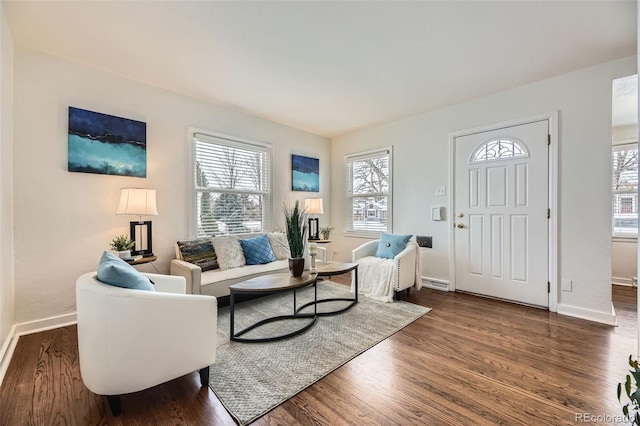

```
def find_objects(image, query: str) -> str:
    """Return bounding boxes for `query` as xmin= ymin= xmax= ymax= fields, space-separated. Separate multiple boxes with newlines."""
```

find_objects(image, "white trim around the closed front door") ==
xmin=447 ymin=111 xmax=560 ymax=312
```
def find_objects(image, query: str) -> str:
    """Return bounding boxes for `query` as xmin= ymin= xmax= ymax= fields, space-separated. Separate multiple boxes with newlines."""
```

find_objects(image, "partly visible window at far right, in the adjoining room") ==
xmin=612 ymin=143 xmax=638 ymax=237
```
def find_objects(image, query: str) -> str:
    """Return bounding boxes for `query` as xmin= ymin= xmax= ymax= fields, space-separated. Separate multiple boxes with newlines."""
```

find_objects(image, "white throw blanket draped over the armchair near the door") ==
xmin=351 ymin=256 xmax=393 ymax=303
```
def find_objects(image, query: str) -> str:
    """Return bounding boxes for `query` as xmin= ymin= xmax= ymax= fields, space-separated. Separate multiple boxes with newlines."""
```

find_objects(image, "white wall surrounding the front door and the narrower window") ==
xmin=331 ymin=57 xmax=636 ymax=322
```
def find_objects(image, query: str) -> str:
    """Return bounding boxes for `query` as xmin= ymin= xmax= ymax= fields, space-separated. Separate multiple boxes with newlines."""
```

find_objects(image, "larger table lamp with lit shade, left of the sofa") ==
xmin=116 ymin=188 xmax=158 ymax=257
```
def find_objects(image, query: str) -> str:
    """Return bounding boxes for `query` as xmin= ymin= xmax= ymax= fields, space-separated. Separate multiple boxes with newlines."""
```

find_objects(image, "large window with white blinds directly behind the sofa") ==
xmin=192 ymin=133 xmax=271 ymax=237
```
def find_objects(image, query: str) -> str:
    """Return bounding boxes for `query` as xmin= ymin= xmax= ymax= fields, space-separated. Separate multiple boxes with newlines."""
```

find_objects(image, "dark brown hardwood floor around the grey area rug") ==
xmin=0 ymin=277 xmax=637 ymax=425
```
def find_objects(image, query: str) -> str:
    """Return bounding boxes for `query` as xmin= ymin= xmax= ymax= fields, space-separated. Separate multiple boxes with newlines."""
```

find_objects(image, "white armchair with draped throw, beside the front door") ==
xmin=351 ymin=236 xmax=422 ymax=302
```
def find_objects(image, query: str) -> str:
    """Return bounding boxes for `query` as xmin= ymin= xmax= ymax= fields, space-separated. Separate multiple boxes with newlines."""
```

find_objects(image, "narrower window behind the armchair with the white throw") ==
xmin=345 ymin=148 xmax=391 ymax=236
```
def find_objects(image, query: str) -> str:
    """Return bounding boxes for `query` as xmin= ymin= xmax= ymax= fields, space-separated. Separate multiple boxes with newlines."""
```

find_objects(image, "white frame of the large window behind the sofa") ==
xmin=188 ymin=127 xmax=273 ymax=238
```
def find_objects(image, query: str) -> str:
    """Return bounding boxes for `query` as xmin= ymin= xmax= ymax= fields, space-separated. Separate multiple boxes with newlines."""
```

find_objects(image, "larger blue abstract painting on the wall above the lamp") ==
xmin=68 ymin=107 xmax=147 ymax=177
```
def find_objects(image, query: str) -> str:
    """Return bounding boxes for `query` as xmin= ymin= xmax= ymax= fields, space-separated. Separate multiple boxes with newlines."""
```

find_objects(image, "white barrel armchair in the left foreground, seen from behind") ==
xmin=76 ymin=272 xmax=218 ymax=416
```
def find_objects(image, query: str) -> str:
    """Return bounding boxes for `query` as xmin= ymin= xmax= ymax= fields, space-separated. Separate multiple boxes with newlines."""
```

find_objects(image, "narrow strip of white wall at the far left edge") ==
xmin=0 ymin=5 xmax=14 ymax=352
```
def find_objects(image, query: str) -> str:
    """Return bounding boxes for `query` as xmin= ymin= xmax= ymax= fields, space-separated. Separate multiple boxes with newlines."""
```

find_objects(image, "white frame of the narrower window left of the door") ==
xmin=344 ymin=146 xmax=393 ymax=238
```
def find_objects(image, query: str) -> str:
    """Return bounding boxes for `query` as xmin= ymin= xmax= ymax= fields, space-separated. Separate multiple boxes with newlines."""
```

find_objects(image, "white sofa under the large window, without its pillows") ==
xmin=169 ymin=234 xmax=289 ymax=297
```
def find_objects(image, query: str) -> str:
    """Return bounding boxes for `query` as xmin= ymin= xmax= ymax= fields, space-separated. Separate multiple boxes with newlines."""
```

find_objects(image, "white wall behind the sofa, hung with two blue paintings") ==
xmin=14 ymin=48 xmax=331 ymax=323
